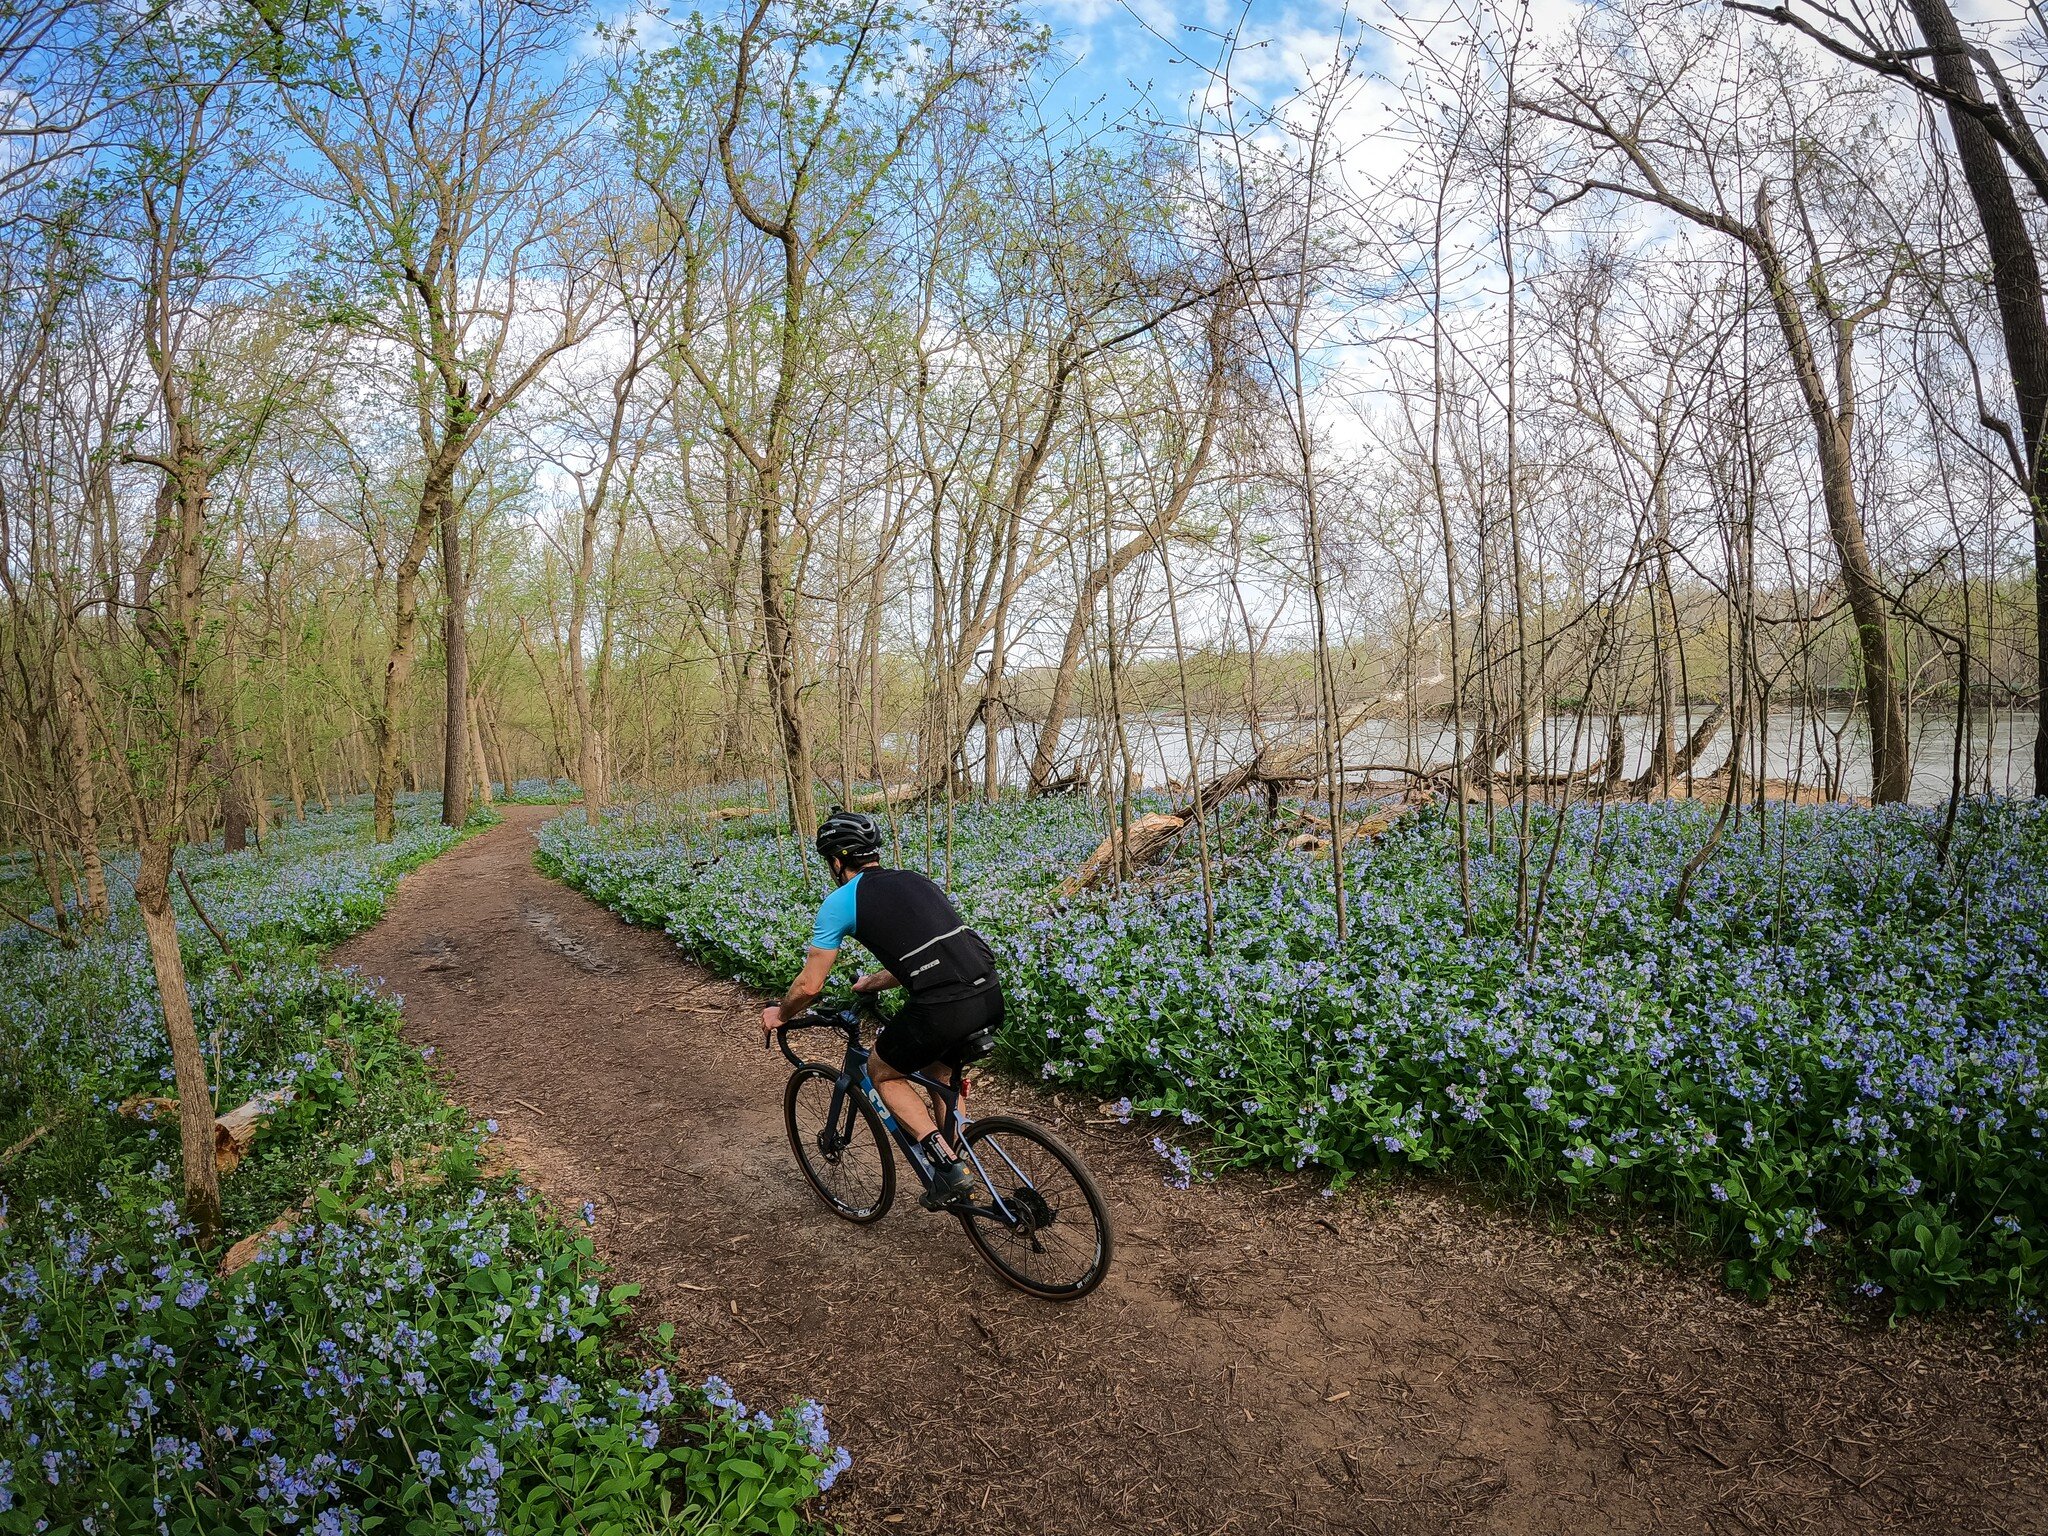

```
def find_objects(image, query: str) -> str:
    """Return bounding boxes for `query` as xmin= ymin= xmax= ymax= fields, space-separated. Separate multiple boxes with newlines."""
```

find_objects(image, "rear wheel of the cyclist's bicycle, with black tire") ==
xmin=961 ymin=1114 xmax=1116 ymax=1300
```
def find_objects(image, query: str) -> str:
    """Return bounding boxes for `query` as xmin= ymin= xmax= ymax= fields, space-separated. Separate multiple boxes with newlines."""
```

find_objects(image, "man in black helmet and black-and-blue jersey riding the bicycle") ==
xmin=762 ymin=805 xmax=1004 ymax=1210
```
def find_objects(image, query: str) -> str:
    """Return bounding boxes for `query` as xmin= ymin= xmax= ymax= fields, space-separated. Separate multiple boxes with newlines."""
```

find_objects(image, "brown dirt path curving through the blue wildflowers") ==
xmin=338 ymin=807 xmax=2048 ymax=1536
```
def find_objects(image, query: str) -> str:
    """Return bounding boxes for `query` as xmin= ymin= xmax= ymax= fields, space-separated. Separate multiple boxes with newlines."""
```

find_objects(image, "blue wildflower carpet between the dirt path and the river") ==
xmin=541 ymin=801 xmax=2048 ymax=1331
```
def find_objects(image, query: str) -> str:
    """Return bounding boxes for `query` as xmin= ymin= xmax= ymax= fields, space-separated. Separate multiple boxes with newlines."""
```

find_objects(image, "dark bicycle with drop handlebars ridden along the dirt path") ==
xmin=774 ymin=1008 xmax=1116 ymax=1300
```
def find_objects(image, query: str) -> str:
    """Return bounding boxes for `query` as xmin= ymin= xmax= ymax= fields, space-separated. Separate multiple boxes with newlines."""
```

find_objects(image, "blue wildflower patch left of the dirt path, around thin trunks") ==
xmin=0 ymin=801 xmax=846 ymax=1536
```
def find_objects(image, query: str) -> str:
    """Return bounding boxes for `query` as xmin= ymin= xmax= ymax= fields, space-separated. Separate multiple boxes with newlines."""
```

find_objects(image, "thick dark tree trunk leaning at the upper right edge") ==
xmin=1907 ymin=0 xmax=2048 ymax=795
